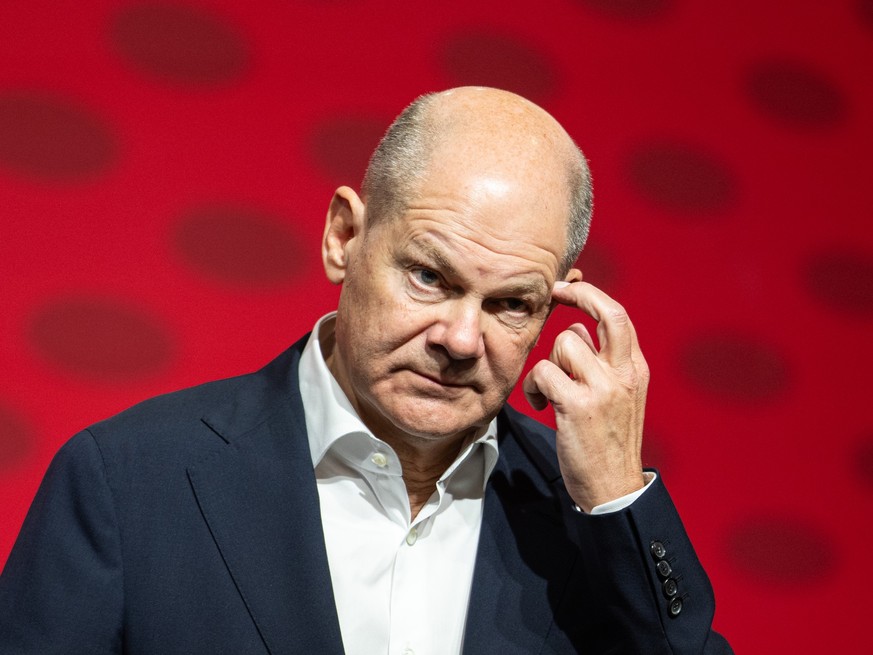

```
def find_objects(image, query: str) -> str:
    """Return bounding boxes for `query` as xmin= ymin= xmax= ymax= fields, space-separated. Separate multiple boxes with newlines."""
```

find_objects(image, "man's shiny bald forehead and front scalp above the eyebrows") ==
xmin=364 ymin=105 xmax=571 ymax=283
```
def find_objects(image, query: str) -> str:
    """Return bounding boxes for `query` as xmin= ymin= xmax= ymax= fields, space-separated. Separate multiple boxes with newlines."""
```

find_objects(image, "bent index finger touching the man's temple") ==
xmin=552 ymin=282 xmax=639 ymax=367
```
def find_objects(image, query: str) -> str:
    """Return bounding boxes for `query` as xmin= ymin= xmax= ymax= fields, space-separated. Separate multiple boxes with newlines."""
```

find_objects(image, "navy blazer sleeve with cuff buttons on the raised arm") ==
xmin=575 ymin=476 xmax=733 ymax=655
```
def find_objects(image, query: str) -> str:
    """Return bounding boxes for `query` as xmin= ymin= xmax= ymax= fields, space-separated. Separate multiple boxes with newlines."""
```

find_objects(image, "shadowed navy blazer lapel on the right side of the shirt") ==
xmin=464 ymin=412 xmax=579 ymax=655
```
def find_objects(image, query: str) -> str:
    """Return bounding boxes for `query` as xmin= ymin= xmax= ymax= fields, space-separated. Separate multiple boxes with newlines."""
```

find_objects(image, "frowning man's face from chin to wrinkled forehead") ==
xmin=329 ymin=149 xmax=568 ymax=446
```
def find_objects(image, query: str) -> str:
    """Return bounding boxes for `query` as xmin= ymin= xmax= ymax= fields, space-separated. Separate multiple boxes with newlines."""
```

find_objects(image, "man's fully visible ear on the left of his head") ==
xmin=321 ymin=186 xmax=365 ymax=284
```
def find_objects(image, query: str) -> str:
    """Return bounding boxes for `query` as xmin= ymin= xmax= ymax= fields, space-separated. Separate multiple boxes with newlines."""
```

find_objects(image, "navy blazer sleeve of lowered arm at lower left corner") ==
xmin=0 ymin=431 xmax=123 ymax=655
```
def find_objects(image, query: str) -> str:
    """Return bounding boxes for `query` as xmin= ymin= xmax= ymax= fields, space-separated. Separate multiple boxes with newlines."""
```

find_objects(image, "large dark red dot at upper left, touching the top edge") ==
xmin=110 ymin=2 xmax=249 ymax=85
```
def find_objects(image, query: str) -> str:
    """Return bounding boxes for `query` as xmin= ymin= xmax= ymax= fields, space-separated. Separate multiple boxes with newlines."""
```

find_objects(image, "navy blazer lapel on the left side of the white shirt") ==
xmin=188 ymin=346 xmax=343 ymax=655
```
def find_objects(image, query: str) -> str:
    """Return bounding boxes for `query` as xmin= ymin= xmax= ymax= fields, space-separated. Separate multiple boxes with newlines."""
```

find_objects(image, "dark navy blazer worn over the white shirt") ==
xmin=0 ymin=339 xmax=730 ymax=655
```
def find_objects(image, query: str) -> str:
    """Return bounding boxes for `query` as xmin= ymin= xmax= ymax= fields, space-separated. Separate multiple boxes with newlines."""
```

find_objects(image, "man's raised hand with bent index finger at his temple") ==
xmin=523 ymin=282 xmax=649 ymax=512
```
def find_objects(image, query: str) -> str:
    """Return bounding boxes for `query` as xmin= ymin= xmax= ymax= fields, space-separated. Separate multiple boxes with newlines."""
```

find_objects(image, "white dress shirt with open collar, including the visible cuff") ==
xmin=299 ymin=314 xmax=648 ymax=655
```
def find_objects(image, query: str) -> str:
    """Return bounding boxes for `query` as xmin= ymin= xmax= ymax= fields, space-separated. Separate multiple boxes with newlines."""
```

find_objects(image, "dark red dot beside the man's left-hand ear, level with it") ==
xmin=173 ymin=204 xmax=309 ymax=287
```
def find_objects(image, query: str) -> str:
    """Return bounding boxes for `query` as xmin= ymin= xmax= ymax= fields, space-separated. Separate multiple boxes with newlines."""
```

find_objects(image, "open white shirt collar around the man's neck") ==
xmin=299 ymin=312 xmax=497 ymax=484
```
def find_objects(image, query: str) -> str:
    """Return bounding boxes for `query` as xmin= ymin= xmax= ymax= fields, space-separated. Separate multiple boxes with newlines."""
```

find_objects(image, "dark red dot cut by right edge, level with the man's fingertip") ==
xmin=803 ymin=251 xmax=873 ymax=318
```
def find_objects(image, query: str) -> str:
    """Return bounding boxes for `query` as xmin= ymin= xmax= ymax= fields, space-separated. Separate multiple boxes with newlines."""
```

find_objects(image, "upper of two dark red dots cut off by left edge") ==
xmin=0 ymin=91 xmax=117 ymax=182
